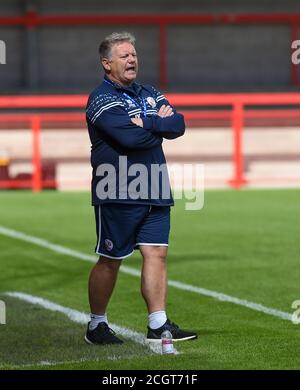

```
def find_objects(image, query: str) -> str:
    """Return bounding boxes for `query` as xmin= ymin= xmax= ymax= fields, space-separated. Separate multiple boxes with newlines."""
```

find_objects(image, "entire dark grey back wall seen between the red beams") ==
xmin=0 ymin=0 xmax=300 ymax=93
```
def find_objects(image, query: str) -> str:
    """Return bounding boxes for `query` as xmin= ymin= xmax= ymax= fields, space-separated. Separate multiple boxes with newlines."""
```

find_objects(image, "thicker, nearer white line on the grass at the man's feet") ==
xmin=5 ymin=291 xmax=170 ymax=354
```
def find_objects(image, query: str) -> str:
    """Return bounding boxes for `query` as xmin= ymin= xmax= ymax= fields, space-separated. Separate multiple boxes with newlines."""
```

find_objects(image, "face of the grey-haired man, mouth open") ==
xmin=102 ymin=42 xmax=138 ymax=86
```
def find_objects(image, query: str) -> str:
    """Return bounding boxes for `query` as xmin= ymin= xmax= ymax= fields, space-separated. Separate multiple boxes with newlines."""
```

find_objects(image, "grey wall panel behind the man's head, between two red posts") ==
xmin=38 ymin=26 xmax=159 ymax=92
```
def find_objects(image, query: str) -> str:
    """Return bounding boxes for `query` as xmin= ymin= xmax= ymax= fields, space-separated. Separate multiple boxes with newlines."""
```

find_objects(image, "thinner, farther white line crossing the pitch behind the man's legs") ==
xmin=0 ymin=226 xmax=292 ymax=321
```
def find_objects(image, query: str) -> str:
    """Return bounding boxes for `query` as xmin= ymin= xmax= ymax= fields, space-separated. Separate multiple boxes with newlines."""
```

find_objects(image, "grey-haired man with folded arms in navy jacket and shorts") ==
xmin=85 ymin=33 xmax=197 ymax=344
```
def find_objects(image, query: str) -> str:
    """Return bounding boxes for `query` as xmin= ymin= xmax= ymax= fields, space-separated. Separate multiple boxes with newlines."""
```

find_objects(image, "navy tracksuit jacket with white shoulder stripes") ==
xmin=86 ymin=76 xmax=185 ymax=206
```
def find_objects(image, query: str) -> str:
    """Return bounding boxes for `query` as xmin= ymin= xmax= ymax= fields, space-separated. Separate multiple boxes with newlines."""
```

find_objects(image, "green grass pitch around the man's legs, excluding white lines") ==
xmin=0 ymin=190 xmax=300 ymax=370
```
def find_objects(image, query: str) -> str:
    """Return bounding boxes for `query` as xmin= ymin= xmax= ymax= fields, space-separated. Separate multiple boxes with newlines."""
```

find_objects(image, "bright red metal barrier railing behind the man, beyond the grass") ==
xmin=0 ymin=93 xmax=300 ymax=192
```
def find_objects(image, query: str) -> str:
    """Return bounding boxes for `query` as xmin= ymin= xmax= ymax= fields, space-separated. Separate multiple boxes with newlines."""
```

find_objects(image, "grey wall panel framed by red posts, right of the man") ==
xmin=168 ymin=25 xmax=291 ymax=91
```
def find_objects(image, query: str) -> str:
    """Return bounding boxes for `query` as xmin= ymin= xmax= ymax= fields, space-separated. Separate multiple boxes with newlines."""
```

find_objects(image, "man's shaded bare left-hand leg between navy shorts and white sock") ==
xmin=89 ymin=256 xmax=121 ymax=315
